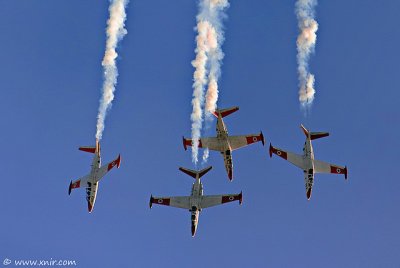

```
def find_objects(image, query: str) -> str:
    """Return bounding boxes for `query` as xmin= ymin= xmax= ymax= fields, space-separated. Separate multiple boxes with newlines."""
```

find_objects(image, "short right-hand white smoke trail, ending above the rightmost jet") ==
xmin=295 ymin=0 xmax=318 ymax=109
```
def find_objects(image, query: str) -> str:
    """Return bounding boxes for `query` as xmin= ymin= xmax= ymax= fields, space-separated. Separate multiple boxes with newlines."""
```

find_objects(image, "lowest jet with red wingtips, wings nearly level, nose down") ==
xmin=149 ymin=166 xmax=243 ymax=237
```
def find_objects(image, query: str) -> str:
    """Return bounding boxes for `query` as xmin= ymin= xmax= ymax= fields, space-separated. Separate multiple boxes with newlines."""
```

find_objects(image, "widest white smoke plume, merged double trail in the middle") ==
xmin=191 ymin=0 xmax=229 ymax=164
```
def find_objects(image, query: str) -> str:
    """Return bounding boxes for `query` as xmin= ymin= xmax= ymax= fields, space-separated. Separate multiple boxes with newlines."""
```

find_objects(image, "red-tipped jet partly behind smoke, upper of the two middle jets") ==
xmin=183 ymin=107 xmax=265 ymax=181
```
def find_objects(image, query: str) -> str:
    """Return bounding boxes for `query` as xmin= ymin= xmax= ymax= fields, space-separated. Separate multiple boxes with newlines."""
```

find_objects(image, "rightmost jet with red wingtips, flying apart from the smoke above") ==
xmin=269 ymin=125 xmax=347 ymax=200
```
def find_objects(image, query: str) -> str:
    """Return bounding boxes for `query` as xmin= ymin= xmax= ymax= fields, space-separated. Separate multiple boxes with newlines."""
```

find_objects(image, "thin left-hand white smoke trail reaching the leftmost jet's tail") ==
xmin=96 ymin=0 xmax=128 ymax=140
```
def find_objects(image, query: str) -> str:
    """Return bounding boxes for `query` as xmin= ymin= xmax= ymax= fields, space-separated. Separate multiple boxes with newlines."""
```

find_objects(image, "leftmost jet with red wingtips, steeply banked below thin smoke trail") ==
xmin=68 ymin=140 xmax=121 ymax=213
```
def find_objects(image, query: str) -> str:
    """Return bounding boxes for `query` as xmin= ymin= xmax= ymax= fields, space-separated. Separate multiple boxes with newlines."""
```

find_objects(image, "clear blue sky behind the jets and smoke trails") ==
xmin=0 ymin=0 xmax=400 ymax=268
